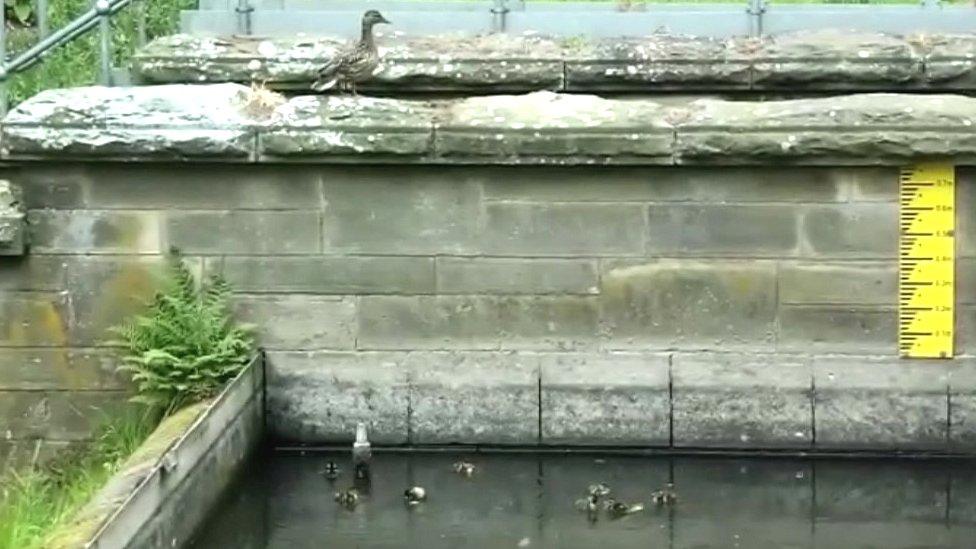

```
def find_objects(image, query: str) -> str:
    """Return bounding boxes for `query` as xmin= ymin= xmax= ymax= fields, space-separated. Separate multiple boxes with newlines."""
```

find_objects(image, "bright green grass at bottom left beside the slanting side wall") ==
xmin=0 ymin=408 xmax=158 ymax=549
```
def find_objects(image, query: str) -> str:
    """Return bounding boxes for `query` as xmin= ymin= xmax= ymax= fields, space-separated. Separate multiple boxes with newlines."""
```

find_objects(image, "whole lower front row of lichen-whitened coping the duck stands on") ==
xmin=0 ymin=84 xmax=976 ymax=165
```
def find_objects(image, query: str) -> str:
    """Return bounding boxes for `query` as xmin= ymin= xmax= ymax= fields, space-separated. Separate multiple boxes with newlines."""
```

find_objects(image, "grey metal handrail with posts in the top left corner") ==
xmin=0 ymin=0 xmax=145 ymax=116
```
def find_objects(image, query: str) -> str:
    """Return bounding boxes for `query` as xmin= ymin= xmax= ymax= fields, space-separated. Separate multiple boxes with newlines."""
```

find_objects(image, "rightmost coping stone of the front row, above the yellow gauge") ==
xmin=674 ymin=93 xmax=976 ymax=165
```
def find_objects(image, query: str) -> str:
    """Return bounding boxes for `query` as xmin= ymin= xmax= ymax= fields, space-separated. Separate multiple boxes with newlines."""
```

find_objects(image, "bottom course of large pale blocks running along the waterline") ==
xmin=268 ymin=351 xmax=976 ymax=454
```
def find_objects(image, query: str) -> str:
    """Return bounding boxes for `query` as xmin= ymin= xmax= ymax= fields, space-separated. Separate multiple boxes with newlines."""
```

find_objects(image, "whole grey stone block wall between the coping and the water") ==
xmin=0 ymin=162 xmax=976 ymax=459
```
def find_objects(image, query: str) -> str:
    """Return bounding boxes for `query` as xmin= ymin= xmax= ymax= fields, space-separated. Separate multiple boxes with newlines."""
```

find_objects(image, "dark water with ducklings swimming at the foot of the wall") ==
xmin=194 ymin=453 xmax=976 ymax=549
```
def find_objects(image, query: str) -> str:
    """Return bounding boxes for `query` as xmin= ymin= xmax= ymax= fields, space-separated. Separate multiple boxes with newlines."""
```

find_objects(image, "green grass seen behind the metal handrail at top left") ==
xmin=7 ymin=0 xmax=196 ymax=105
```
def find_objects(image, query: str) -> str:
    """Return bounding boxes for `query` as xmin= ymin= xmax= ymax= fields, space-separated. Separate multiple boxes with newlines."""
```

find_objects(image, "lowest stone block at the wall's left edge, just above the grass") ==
xmin=0 ymin=391 xmax=128 ymax=441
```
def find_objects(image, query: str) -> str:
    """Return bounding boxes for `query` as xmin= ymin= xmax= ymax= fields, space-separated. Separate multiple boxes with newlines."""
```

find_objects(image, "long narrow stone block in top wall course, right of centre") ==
xmin=480 ymin=166 xmax=848 ymax=203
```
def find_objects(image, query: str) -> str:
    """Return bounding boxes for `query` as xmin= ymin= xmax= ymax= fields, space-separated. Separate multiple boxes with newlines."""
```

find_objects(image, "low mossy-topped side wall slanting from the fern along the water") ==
xmin=45 ymin=357 xmax=264 ymax=549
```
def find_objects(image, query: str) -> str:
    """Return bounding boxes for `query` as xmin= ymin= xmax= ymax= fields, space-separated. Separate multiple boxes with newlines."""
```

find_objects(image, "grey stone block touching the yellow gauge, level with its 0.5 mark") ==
xmin=803 ymin=203 xmax=898 ymax=260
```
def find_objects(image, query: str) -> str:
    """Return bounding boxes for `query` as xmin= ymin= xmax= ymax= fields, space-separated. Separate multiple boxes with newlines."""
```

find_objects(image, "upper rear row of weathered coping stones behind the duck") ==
xmin=133 ymin=30 xmax=976 ymax=94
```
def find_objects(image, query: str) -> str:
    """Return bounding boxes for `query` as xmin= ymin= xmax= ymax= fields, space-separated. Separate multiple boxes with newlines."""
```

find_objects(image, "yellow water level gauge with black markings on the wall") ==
xmin=898 ymin=162 xmax=956 ymax=358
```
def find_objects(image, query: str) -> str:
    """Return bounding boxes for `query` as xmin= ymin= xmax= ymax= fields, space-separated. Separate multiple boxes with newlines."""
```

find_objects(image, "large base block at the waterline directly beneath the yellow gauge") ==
xmin=814 ymin=357 xmax=949 ymax=451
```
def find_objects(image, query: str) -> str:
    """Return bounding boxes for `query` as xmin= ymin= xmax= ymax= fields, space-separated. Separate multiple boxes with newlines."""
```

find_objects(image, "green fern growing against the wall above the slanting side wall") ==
xmin=113 ymin=251 xmax=254 ymax=415
